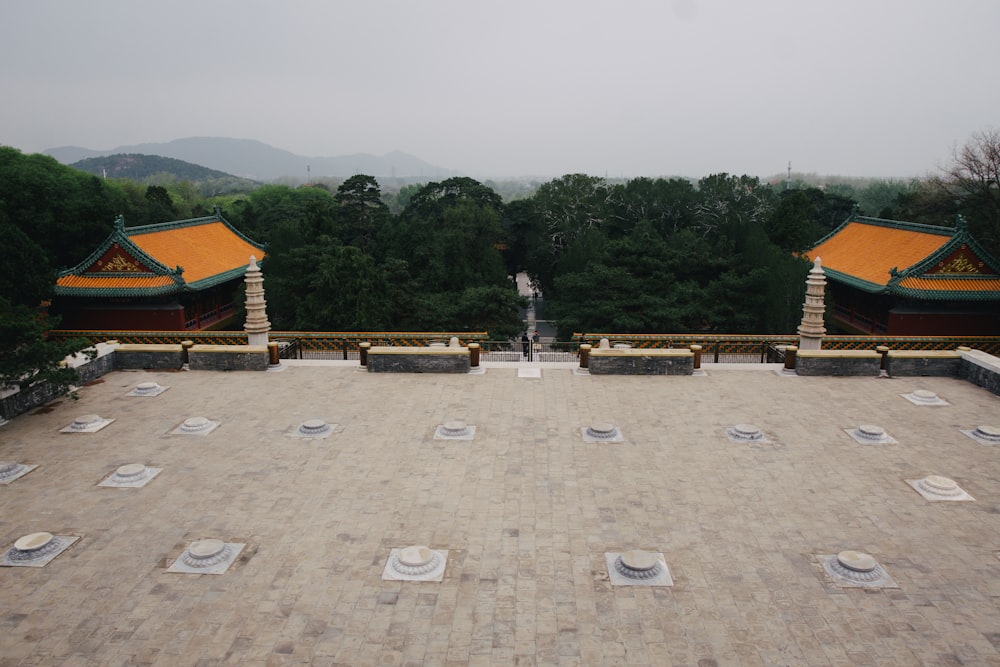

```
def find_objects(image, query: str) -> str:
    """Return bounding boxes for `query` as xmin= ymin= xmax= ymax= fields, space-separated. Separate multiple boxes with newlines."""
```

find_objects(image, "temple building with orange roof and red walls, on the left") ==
xmin=52 ymin=208 xmax=266 ymax=331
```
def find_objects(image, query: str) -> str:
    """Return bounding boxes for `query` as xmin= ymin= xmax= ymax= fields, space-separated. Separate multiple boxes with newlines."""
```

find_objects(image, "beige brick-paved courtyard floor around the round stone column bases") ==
xmin=0 ymin=362 xmax=1000 ymax=667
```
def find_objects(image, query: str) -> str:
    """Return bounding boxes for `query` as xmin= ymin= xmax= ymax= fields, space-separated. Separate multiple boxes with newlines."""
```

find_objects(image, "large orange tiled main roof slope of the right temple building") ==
xmin=808 ymin=221 xmax=951 ymax=285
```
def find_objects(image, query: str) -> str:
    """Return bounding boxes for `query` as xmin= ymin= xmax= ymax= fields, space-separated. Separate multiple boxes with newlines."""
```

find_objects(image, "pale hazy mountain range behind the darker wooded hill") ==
xmin=44 ymin=137 xmax=459 ymax=181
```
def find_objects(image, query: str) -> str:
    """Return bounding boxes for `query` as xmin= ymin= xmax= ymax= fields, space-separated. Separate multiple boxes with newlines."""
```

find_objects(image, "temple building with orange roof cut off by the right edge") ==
xmin=806 ymin=215 xmax=1000 ymax=336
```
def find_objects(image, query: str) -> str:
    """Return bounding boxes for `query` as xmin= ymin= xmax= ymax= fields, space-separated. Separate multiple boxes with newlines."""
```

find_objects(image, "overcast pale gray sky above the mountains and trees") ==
xmin=0 ymin=0 xmax=1000 ymax=178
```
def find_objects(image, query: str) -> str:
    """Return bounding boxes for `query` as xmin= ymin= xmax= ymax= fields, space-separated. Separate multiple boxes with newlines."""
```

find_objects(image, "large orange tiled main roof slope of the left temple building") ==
xmin=126 ymin=221 xmax=263 ymax=283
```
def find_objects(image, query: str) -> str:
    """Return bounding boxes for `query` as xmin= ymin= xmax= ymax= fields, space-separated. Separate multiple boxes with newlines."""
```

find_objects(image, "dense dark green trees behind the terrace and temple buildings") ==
xmin=0 ymin=132 xmax=1000 ymax=358
